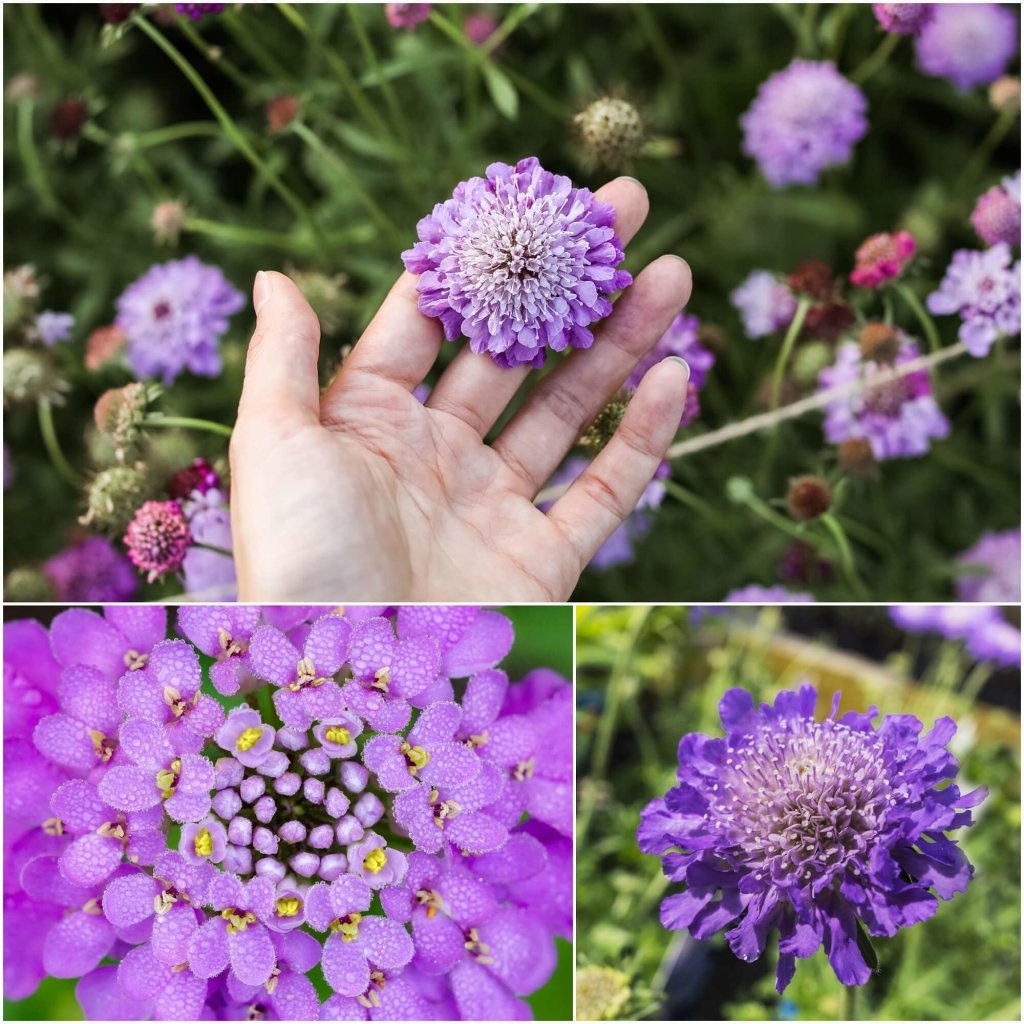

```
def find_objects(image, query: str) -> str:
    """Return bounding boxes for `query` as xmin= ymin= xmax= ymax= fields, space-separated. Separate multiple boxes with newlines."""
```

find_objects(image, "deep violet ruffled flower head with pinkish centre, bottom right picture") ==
xmin=637 ymin=686 xmax=986 ymax=992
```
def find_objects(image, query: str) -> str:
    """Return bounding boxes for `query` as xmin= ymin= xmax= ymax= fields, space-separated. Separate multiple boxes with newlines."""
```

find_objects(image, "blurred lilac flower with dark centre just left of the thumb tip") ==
xmin=116 ymin=256 xmax=245 ymax=384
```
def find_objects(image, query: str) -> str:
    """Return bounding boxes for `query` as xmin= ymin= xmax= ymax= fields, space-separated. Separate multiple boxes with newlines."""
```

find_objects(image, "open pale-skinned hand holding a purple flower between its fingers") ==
xmin=230 ymin=178 xmax=691 ymax=603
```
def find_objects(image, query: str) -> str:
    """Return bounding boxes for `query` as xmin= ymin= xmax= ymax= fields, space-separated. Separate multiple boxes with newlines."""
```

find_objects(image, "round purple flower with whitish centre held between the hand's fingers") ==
xmin=402 ymin=157 xmax=633 ymax=367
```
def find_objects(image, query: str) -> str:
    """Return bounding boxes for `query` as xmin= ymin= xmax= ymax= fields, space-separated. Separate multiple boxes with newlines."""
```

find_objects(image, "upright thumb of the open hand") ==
xmin=239 ymin=270 xmax=319 ymax=424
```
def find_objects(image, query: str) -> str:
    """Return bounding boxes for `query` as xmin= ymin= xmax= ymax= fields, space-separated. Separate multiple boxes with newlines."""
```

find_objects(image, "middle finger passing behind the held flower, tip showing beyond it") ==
xmin=417 ymin=178 xmax=649 ymax=437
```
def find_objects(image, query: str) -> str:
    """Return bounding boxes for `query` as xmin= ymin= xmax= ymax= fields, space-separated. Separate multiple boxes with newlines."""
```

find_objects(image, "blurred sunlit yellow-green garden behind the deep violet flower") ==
xmin=577 ymin=607 xmax=1021 ymax=1020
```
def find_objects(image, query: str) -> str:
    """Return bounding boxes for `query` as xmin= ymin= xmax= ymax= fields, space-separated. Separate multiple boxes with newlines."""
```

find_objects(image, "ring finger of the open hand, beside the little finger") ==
xmin=494 ymin=256 xmax=692 ymax=498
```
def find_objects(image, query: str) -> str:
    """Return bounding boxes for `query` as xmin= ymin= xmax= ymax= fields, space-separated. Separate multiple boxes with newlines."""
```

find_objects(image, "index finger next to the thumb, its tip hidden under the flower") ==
xmin=326 ymin=270 xmax=442 ymax=400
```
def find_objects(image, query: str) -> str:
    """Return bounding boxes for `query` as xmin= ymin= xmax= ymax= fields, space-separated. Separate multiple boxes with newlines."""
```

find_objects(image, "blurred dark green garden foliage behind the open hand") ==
xmin=3 ymin=3 xmax=1020 ymax=600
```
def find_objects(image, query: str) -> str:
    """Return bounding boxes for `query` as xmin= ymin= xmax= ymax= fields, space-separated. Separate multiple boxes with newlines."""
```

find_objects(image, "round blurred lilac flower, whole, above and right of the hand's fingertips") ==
xmin=739 ymin=60 xmax=867 ymax=187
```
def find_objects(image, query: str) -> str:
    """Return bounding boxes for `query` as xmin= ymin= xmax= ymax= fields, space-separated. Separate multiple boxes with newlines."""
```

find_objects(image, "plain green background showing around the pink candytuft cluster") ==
xmin=3 ymin=605 xmax=572 ymax=1021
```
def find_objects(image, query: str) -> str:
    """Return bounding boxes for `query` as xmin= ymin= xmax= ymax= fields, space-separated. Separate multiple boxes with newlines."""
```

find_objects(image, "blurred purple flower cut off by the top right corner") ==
xmin=915 ymin=3 xmax=1020 ymax=91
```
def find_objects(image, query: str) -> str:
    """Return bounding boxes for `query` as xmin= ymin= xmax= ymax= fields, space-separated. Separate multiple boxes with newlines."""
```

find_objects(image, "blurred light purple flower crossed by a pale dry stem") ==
xmin=818 ymin=341 xmax=949 ymax=462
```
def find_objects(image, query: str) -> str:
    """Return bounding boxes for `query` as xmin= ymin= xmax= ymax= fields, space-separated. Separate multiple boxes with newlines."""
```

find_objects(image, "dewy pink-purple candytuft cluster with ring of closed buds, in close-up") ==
xmin=4 ymin=605 xmax=572 ymax=1020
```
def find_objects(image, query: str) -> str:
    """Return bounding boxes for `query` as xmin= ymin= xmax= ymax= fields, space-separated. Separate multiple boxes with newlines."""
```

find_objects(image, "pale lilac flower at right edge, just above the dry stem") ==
xmin=927 ymin=242 xmax=1021 ymax=357
